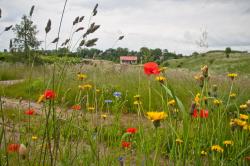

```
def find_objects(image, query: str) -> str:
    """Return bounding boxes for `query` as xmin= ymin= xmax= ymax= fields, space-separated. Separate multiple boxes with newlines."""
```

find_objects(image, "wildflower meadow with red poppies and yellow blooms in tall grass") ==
xmin=0 ymin=58 xmax=250 ymax=165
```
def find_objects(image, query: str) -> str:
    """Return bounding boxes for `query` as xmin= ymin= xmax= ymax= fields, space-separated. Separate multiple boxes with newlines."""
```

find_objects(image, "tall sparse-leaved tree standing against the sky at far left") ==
xmin=13 ymin=15 xmax=41 ymax=54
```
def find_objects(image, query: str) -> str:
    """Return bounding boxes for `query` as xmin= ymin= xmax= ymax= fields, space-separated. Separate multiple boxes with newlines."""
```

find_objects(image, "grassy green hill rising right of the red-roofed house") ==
xmin=165 ymin=51 xmax=250 ymax=75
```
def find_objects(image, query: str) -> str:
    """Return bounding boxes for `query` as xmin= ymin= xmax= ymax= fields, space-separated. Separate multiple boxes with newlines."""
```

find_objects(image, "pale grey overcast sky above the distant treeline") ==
xmin=0 ymin=0 xmax=250 ymax=55
